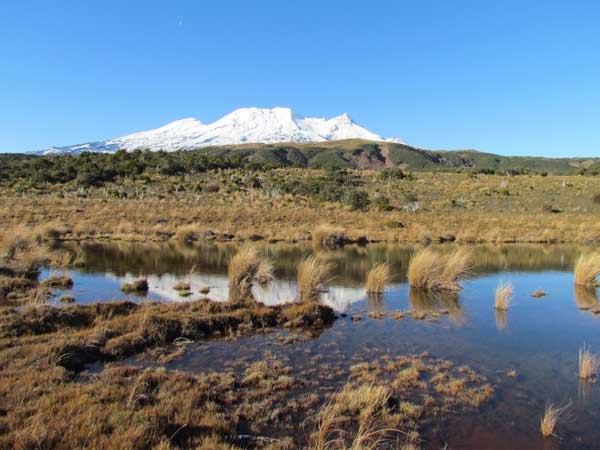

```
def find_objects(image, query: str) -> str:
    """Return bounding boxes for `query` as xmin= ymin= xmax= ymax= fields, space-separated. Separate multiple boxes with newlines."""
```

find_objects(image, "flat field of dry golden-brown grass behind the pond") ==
xmin=5 ymin=169 xmax=600 ymax=243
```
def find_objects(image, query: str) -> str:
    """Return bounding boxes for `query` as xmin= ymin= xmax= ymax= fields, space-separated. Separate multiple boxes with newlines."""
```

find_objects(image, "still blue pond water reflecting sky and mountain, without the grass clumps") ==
xmin=42 ymin=242 xmax=600 ymax=450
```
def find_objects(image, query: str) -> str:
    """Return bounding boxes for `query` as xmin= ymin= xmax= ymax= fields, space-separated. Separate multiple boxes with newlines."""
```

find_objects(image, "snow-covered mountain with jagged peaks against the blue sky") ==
xmin=39 ymin=108 xmax=402 ymax=155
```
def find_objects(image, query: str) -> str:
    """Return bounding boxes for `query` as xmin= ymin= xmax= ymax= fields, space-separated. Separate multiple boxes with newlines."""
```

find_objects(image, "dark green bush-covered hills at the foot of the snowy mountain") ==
xmin=0 ymin=139 xmax=600 ymax=182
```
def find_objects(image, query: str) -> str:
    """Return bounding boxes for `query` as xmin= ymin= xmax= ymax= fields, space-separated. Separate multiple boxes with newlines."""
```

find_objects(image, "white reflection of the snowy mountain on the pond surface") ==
xmin=107 ymin=274 xmax=365 ymax=312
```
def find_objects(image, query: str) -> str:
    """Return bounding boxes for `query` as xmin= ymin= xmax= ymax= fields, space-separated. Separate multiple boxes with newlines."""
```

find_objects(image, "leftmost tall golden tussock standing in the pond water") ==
xmin=227 ymin=244 xmax=273 ymax=301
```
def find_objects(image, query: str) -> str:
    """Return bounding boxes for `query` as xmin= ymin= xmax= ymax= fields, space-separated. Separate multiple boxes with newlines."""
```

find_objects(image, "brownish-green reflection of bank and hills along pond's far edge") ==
xmin=69 ymin=242 xmax=592 ymax=286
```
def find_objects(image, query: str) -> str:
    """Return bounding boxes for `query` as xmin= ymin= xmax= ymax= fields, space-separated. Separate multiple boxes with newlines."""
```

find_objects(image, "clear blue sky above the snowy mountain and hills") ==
xmin=0 ymin=0 xmax=600 ymax=156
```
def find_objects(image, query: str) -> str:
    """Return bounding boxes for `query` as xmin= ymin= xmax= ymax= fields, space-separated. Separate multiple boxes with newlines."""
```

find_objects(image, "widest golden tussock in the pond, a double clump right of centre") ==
xmin=408 ymin=248 xmax=472 ymax=291
